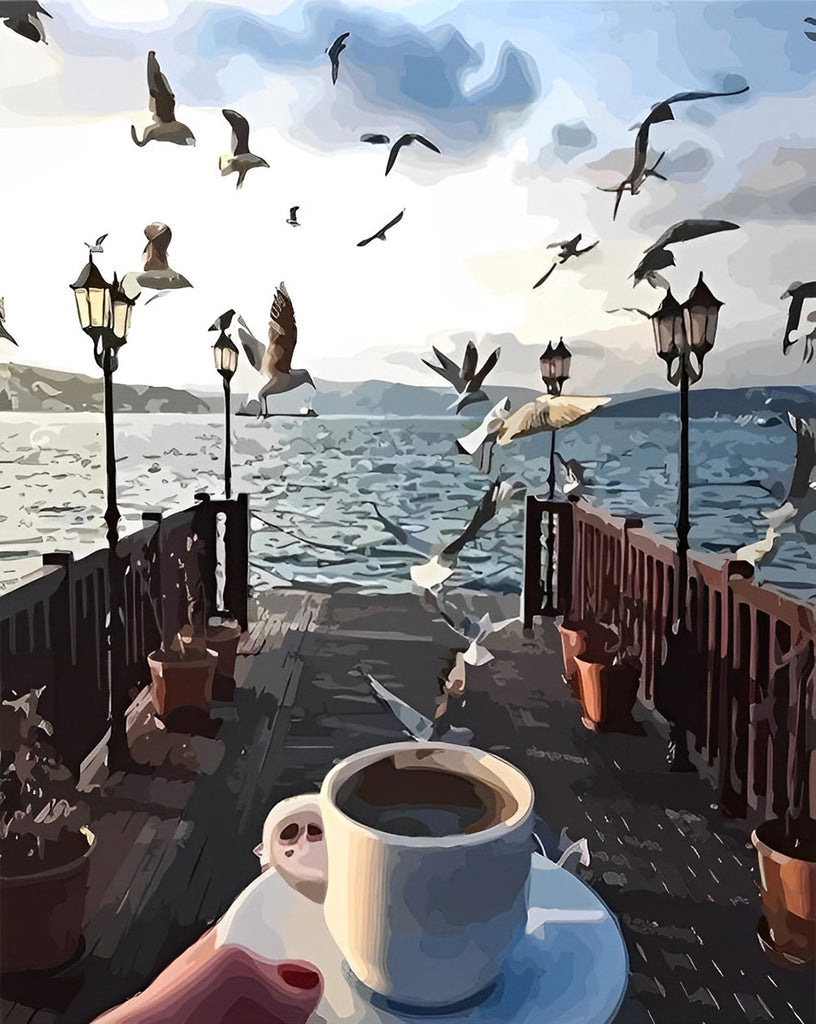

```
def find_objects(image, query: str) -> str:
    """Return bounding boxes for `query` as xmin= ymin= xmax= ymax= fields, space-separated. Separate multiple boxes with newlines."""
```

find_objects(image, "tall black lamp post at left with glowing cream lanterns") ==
xmin=71 ymin=254 xmax=138 ymax=770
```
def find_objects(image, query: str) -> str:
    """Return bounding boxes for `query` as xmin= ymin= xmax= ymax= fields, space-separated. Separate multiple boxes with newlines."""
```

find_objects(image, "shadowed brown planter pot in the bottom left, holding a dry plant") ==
xmin=0 ymin=831 xmax=96 ymax=974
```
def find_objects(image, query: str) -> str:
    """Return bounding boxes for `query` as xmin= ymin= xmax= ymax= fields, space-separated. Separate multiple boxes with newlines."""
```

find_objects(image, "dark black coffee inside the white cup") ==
xmin=336 ymin=751 xmax=517 ymax=837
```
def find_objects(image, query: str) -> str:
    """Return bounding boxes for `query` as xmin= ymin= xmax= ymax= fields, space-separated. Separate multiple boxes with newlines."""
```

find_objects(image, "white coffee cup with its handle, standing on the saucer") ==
xmin=264 ymin=741 xmax=533 ymax=1008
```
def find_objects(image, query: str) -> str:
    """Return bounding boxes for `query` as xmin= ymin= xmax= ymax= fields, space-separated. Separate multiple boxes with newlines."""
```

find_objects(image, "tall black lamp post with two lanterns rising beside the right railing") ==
xmin=651 ymin=272 xmax=723 ymax=771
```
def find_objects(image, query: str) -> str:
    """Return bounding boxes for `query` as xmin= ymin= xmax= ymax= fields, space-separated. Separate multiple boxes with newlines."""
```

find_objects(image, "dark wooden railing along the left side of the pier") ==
xmin=0 ymin=495 xmax=249 ymax=771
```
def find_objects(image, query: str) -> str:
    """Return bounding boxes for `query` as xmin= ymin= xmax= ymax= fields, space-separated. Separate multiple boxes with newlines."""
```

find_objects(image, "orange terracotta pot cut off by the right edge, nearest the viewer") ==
xmin=750 ymin=818 xmax=816 ymax=970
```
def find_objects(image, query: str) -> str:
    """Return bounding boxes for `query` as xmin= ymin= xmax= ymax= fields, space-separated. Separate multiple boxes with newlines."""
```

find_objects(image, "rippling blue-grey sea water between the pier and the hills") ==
xmin=0 ymin=406 xmax=816 ymax=599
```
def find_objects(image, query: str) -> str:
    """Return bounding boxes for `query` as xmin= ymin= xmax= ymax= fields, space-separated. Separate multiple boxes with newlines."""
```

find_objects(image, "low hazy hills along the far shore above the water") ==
xmin=0 ymin=362 xmax=816 ymax=420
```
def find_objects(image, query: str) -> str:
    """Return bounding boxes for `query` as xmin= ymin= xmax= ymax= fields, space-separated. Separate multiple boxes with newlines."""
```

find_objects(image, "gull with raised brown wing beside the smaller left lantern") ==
xmin=210 ymin=281 xmax=314 ymax=417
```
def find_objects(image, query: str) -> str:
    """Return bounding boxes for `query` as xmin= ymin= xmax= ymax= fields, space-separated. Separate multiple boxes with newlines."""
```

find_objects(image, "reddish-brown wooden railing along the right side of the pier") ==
xmin=522 ymin=498 xmax=816 ymax=818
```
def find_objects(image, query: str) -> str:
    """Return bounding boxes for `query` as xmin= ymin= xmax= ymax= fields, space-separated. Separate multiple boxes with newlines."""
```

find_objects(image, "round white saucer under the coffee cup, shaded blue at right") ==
xmin=216 ymin=854 xmax=629 ymax=1024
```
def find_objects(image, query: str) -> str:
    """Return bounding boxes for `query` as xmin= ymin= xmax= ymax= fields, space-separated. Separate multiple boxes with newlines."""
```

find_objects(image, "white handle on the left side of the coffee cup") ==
xmin=255 ymin=793 xmax=329 ymax=903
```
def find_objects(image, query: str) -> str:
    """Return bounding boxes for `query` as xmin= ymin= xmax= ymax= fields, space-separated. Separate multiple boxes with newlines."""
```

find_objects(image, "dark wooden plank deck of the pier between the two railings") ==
xmin=2 ymin=590 xmax=816 ymax=1024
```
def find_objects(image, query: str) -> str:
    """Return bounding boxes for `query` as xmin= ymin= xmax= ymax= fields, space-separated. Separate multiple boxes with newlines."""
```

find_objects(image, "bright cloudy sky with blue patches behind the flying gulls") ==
xmin=0 ymin=0 xmax=816 ymax=393
